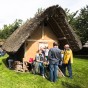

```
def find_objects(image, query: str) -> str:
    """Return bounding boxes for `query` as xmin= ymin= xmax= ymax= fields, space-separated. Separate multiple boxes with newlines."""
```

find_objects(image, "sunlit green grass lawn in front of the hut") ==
xmin=0 ymin=56 xmax=88 ymax=88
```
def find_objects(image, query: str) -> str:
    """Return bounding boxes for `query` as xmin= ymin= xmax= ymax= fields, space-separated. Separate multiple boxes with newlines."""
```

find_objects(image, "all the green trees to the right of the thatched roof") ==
xmin=65 ymin=6 xmax=88 ymax=44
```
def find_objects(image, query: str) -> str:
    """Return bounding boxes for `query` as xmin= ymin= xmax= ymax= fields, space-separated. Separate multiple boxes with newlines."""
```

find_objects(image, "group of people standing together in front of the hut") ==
xmin=35 ymin=42 xmax=73 ymax=82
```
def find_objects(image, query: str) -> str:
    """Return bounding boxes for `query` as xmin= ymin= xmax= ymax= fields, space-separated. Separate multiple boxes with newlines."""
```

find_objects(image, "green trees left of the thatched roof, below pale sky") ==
xmin=0 ymin=19 xmax=22 ymax=39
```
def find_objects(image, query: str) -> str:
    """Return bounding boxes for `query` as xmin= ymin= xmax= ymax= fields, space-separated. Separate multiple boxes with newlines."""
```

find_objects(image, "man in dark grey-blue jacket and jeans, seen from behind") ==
xmin=48 ymin=42 xmax=61 ymax=82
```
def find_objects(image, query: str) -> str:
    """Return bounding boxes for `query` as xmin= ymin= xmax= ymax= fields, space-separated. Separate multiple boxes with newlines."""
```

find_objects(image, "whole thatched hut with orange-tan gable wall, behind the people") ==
xmin=3 ymin=5 xmax=82 ymax=61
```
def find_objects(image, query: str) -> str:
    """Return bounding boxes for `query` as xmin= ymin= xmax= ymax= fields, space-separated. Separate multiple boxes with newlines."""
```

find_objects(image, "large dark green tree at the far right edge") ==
xmin=75 ymin=6 xmax=88 ymax=43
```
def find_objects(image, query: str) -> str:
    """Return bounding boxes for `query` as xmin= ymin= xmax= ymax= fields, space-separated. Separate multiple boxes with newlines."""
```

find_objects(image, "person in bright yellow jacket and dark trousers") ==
xmin=63 ymin=44 xmax=73 ymax=78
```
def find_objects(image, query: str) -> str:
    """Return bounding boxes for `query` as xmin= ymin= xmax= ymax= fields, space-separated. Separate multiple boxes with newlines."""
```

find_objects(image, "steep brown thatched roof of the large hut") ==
xmin=3 ymin=6 xmax=82 ymax=52
